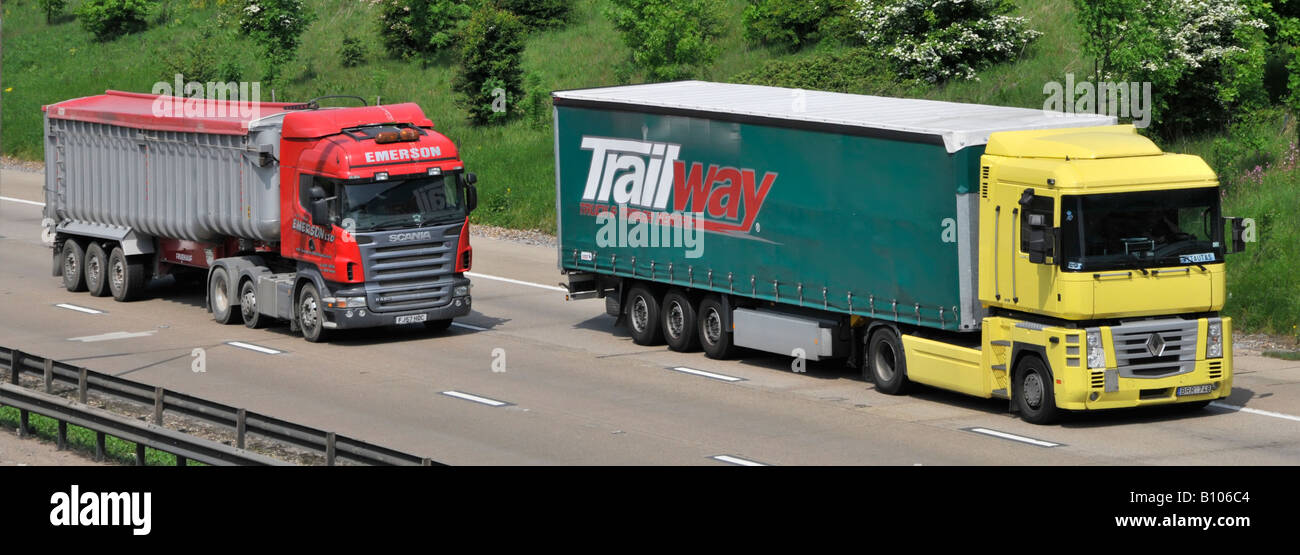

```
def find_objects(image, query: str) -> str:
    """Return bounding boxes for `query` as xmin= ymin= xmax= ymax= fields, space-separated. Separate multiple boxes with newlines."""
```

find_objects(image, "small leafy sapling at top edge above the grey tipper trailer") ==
xmin=239 ymin=0 xmax=316 ymax=83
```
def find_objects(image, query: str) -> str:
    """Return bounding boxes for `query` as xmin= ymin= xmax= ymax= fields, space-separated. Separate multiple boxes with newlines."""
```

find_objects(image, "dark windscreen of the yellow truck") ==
xmin=1061 ymin=187 xmax=1225 ymax=272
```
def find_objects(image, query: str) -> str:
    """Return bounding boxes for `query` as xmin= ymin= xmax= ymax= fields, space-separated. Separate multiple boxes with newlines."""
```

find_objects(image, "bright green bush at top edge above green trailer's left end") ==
xmin=606 ymin=0 xmax=723 ymax=81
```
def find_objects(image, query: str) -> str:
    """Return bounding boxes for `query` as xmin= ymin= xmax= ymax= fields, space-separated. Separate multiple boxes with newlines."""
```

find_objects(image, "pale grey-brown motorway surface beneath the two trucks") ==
xmin=0 ymin=170 xmax=1300 ymax=465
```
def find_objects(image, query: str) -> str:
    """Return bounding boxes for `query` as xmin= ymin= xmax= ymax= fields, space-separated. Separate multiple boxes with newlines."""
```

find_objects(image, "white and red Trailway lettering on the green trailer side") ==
xmin=580 ymin=136 xmax=777 ymax=235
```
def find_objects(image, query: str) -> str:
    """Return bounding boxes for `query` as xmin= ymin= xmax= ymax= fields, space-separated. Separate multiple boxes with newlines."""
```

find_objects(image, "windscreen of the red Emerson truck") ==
xmin=321 ymin=174 xmax=465 ymax=231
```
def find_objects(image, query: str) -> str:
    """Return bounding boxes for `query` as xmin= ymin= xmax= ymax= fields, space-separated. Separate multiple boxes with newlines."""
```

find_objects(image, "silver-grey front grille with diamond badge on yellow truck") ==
xmin=1110 ymin=320 xmax=1197 ymax=378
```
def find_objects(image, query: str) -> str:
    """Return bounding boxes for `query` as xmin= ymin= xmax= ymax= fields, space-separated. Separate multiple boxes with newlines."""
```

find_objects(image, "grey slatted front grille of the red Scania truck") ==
xmin=358 ymin=224 xmax=462 ymax=312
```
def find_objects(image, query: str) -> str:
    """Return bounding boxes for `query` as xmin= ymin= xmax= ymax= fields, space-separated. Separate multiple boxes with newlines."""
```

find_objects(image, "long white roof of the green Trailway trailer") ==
xmin=553 ymin=81 xmax=1117 ymax=152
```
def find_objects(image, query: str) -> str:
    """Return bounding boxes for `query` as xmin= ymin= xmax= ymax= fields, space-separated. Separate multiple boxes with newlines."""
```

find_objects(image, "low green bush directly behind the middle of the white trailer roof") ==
xmin=731 ymin=48 xmax=926 ymax=96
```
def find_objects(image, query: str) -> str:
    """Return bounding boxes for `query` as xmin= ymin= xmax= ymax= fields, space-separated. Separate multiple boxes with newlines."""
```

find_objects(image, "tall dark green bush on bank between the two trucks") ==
xmin=452 ymin=5 xmax=527 ymax=125
